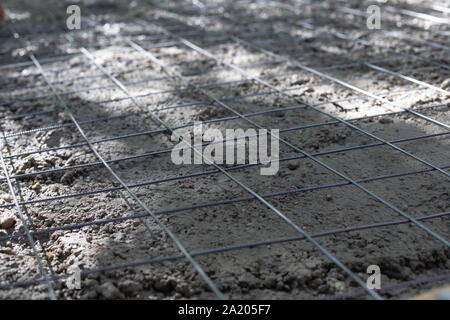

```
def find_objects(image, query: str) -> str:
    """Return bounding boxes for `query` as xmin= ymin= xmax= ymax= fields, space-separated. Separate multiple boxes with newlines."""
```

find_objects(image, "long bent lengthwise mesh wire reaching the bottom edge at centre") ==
xmin=12 ymin=27 xmax=226 ymax=299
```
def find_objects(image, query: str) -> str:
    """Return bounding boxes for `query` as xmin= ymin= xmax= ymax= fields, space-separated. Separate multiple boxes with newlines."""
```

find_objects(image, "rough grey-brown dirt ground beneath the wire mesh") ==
xmin=0 ymin=0 xmax=450 ymax=299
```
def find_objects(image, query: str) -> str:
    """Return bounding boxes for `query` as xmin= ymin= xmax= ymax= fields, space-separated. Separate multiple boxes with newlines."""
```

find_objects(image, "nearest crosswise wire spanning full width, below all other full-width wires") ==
xmin=0 ymin=212 xmax=450 ymax=296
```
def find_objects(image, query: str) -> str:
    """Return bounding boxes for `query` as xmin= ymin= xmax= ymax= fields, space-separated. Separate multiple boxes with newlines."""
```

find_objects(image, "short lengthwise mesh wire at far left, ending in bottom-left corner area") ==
xmin=0 ymin=135 xmax=56 ymax=300
